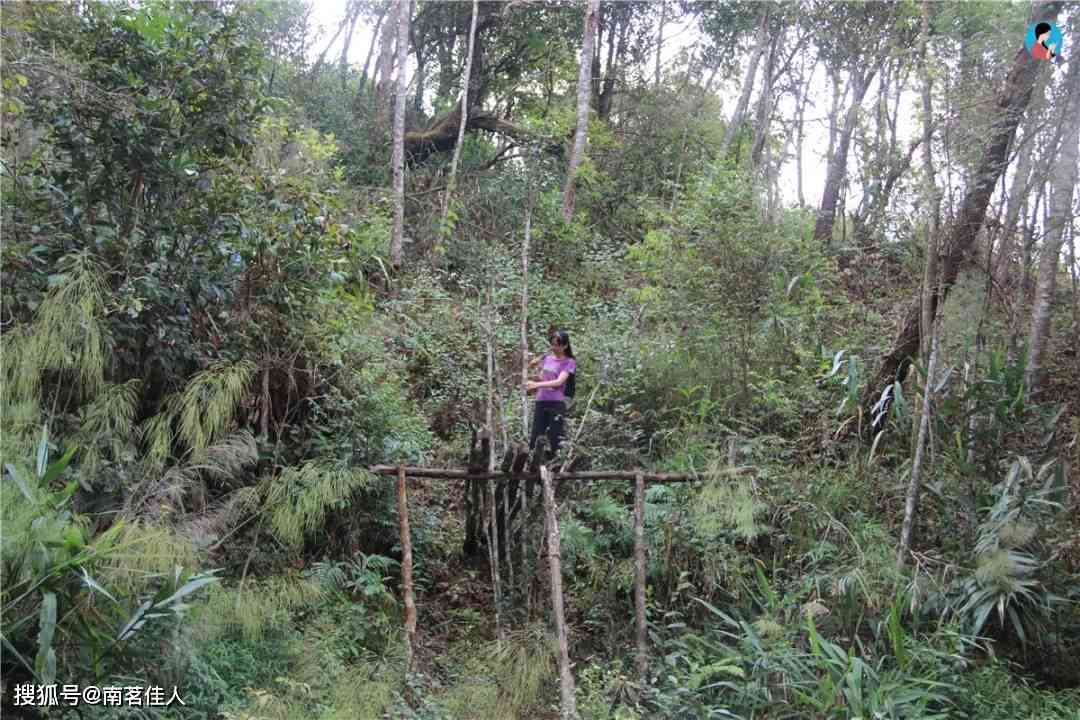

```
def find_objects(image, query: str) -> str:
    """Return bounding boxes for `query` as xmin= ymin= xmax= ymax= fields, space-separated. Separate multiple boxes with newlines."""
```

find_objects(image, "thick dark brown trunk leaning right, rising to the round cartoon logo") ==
xmin=867 ymin=2 xmax=1062 ymax=397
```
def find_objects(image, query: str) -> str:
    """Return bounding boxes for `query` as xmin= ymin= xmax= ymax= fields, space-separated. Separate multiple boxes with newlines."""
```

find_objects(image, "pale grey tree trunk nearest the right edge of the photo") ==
xmin=1024 ymin=19 xmax=1080 ymax=394
